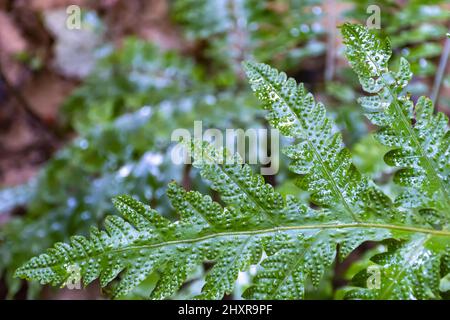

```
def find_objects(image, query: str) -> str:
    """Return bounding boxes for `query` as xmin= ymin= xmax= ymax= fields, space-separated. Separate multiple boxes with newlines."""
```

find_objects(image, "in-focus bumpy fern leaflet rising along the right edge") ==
xmin=342 ymin=23 xmax=450 ymax=216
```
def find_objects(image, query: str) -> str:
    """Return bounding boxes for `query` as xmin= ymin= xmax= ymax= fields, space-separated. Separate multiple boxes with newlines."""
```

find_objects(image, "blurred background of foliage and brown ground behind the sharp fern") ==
xmin=0 ymin=0 xmax=450 ymax=299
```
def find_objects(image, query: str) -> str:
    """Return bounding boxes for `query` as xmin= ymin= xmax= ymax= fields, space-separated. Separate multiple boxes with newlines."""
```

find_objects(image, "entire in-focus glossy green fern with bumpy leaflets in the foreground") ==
xmin=16 ymin=24 xmax=450 ymax=299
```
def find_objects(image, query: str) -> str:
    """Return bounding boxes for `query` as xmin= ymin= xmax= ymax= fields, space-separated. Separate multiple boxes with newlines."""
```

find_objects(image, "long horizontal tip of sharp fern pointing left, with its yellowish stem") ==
xmin=16 ymin=144 xmax=450 ymax=299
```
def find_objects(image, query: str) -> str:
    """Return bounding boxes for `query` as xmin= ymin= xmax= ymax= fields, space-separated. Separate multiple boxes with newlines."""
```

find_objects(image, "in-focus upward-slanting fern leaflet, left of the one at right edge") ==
xmin=244 ymin=62 xmax=395 ymax=221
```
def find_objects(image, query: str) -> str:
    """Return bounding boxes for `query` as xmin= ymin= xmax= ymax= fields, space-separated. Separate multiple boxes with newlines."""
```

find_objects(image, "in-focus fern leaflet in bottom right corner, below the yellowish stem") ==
xmin=346 ymin=235 xmax=450 ymax=300
